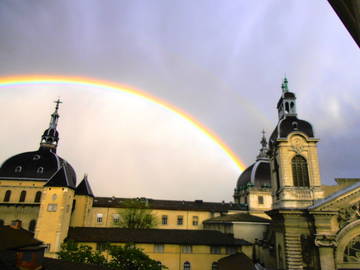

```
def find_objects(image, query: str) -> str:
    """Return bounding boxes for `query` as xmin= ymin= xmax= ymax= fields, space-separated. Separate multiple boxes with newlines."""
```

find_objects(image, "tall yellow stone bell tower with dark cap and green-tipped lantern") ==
xmin=269 ymin=78 xmax=323 ymax=209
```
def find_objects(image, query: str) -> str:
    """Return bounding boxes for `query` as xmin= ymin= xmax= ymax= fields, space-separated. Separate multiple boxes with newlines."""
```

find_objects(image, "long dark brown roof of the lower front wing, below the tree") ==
xmin=68 ymin=227 xmax=251 ymax=246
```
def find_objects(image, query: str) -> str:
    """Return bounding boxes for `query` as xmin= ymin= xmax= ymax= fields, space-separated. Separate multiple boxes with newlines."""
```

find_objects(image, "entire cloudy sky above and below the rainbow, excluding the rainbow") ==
xmin=0 ymin=0 xmax=360 ymax=201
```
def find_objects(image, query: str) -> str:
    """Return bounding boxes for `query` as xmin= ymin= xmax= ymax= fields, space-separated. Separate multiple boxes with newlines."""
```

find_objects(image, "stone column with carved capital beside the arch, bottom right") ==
xmin=315 ymin=234 xmax=336 ymax=270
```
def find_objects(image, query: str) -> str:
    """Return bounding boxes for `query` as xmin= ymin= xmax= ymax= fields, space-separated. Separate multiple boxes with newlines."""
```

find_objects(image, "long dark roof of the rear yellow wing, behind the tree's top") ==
xmin=93 ymin=197 xmax=247 ymax=212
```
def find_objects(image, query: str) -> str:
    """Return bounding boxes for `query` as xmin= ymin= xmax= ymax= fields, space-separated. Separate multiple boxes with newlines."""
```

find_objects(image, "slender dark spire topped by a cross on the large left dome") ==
xmin=40 ymin=99 xmax=62 ymax=153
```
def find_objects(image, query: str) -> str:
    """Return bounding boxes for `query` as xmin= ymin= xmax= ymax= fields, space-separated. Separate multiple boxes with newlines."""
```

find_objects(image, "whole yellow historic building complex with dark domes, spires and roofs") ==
xmin=0 ymin=78 xmax=360 ymax=270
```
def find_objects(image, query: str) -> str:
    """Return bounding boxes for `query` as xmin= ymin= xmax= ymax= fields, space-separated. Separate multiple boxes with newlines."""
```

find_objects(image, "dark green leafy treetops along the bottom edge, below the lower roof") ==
xmin=57 ymin=240 xmax=167 ymax=270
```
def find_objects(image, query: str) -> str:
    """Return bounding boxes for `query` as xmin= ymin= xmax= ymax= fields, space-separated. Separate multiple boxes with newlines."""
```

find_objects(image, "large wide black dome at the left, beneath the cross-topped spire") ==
xmin=0 ymin=147 xmax=76 ymax=187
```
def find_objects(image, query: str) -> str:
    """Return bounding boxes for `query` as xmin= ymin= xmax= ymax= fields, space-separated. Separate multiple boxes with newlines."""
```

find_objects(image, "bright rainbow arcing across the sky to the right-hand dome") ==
xmin=0 ymin=75 xmax=246 ymax=171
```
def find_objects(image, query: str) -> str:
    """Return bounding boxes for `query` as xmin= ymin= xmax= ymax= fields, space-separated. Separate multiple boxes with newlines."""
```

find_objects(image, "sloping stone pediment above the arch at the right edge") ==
xmin=308 ymin=182 xmax=360 ymax=212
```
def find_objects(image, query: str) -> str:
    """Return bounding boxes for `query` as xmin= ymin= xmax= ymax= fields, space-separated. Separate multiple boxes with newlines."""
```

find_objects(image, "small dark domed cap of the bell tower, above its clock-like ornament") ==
xmin=269 ymin=116 xmax=314 ymax=148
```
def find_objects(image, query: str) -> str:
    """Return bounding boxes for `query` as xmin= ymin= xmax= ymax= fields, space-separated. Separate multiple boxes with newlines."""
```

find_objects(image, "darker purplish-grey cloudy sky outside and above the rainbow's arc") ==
xmin=0 ymin=0 xmax=360 ymax=199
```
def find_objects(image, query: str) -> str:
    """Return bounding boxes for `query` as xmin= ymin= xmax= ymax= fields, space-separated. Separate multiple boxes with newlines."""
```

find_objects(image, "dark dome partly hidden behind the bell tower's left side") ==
xmin=236 ymin=159 xmax=271 ymax=189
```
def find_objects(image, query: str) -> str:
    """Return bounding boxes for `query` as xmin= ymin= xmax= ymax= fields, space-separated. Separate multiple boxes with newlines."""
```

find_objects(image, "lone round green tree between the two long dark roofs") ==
xmin=116 ymin=199 xmax=157 ymax=229
